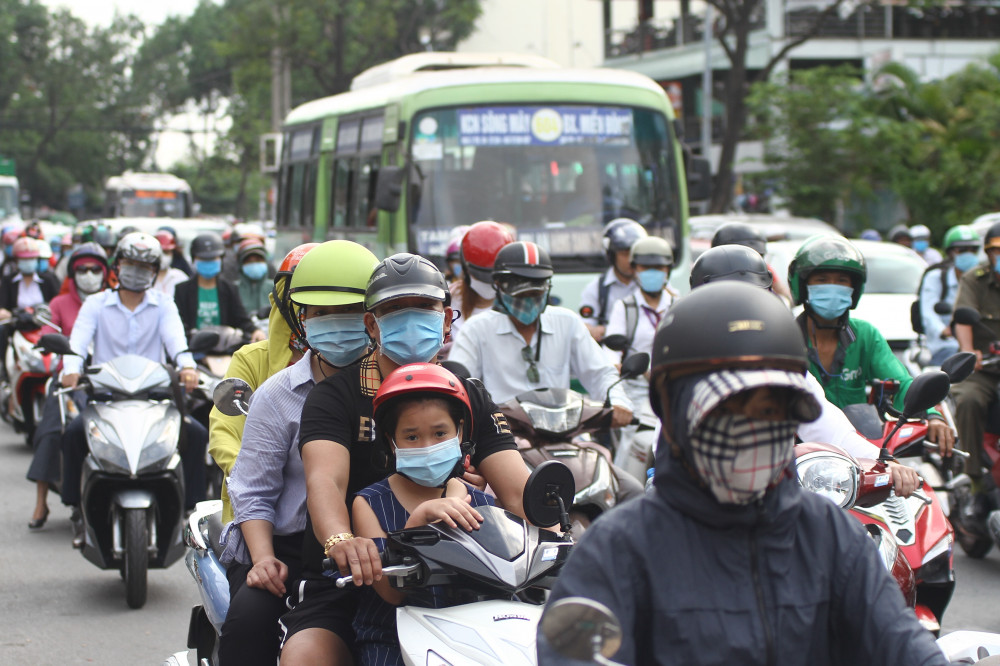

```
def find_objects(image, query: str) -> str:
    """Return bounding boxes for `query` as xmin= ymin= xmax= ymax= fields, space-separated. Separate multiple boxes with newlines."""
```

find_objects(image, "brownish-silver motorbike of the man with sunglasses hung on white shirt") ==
xmin=500 ymin=353 xmax=649 ymax=530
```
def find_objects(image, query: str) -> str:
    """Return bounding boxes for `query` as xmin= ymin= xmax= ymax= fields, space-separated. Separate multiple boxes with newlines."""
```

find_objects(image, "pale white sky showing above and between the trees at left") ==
xmin=42 ymin=0 xmax=222 ymax=169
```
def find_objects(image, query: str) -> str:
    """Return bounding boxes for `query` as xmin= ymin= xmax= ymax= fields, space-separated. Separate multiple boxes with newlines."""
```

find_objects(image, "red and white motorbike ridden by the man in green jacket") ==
xmin=844 ymin=366 xmax=970 ymax=633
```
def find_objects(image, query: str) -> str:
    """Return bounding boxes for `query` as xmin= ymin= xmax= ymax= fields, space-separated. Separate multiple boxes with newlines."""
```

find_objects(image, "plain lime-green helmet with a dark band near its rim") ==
xmin=288 ymin=240 xmax=378 ymax=305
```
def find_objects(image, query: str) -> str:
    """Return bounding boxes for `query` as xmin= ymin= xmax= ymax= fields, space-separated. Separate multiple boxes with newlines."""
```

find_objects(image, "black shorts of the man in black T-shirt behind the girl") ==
xmin=279 ymin=574 xmax=358 ymax=652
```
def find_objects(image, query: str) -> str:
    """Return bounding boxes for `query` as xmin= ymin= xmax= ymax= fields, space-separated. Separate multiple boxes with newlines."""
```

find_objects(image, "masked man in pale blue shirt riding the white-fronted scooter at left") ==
xmin=61 ymin=232 xmax=208 ymax=545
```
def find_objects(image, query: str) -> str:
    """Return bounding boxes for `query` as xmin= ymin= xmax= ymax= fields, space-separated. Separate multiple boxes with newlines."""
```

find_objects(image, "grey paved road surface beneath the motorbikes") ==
xmin=0 ymin=424 xmax=1000 ymax=666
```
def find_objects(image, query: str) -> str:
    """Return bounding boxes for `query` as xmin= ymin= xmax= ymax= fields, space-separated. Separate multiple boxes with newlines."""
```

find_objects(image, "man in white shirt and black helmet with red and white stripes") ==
xmin=448 ymin=242 xmax=632 ymax=428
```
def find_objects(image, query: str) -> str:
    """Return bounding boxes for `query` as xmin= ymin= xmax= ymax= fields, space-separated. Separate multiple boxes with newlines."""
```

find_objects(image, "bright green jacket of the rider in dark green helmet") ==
xmin=798 ymin=313 xmax=937 ymax=414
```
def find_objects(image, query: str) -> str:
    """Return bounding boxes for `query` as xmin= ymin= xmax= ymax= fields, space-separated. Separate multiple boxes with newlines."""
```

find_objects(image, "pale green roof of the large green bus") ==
xmin=285 ymin=67 xmax=665 ymax=126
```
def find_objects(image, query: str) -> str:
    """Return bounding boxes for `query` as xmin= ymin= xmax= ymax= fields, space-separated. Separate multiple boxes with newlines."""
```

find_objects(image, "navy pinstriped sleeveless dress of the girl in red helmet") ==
xmin=354 ymin=479 xmax=494 ymax=666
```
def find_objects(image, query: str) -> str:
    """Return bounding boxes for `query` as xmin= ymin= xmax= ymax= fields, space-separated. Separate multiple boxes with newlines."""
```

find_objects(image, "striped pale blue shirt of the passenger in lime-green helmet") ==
xmin=221 ymin=352 xmax=316 ymax=564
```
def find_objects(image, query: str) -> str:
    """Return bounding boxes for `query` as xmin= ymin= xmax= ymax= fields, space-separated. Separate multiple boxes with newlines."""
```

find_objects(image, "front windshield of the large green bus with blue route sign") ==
xmin=409 ymin=105 xmax=681 ymax=270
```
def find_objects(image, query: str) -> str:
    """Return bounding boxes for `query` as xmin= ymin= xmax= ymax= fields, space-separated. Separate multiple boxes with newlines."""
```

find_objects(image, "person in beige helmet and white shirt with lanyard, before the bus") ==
xmin=580 ymin=217 xmax=648 ymax=341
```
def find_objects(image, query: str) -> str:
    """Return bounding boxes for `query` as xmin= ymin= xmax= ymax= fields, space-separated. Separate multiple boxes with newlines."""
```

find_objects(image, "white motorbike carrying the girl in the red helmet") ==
xmin=324 ymin=461 xmax=574 ymax=666
